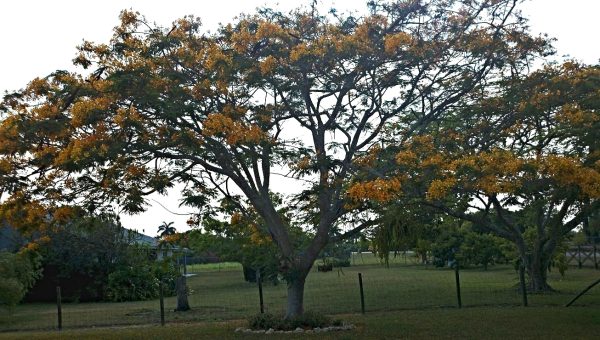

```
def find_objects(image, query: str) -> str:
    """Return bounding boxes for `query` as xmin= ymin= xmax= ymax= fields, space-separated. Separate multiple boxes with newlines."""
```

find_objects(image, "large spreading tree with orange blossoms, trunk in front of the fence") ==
xmin=0 ymin=0 xmax=548 ymax=317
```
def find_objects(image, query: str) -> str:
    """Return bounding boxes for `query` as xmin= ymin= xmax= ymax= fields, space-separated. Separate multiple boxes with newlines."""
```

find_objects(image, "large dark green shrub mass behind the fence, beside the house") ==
xmin=34 ymin=213 xmax=178 ymax=301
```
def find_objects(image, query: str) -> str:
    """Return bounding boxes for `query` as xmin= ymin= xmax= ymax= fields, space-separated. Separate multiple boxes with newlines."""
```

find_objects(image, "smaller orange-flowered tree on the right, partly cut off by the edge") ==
xmin=356 ymin=62 xmax=600 ymax=291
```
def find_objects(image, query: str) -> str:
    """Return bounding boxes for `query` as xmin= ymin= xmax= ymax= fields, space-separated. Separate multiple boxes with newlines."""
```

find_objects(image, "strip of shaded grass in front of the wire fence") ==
xmin=0 ymin=307 xmax=600 ymax=340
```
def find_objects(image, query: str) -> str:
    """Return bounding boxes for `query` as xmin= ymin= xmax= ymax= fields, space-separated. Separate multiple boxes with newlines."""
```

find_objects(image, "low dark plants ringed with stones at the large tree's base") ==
xmin=248 ymin=311 xmax=342 ymax=331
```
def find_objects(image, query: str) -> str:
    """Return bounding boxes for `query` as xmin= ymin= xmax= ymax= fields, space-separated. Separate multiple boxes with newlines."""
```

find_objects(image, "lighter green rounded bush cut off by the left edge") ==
xmin=0 ymin=249 xmax=41 ymax=309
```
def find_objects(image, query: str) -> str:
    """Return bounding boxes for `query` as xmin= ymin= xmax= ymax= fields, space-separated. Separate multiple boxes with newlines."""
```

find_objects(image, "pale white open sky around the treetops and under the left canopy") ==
xmin=0 ymin=0 xmax=600 ymax=235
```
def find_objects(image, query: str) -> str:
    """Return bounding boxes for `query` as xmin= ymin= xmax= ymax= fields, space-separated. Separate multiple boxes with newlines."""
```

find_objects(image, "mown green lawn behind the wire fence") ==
xmin=0 ymin=254 xmax=600 ymax=331
